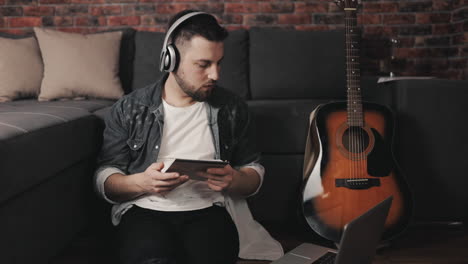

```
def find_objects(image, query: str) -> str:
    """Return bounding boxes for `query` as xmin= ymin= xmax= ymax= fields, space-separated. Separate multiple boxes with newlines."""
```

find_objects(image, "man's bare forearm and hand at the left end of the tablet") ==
xmin=104 ymin=163 xmax=189 ymax=202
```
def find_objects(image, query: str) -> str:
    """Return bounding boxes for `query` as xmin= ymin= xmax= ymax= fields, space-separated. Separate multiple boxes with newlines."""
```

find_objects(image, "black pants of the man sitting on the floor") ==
xmin=118 ymin=206 xmax=239 ymax=264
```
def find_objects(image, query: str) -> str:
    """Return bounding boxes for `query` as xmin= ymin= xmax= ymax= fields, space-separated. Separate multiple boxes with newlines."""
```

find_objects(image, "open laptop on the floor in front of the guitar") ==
xmin=271 ymin=196 xmax=393 ymax=264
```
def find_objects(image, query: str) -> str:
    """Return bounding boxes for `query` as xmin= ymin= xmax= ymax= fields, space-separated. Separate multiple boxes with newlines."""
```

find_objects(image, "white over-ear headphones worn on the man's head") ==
xmin=159 ymin=12 xmax=210 ymax=72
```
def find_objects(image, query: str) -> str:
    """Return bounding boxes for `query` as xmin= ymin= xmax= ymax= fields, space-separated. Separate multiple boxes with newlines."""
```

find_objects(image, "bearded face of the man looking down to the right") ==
xmin=174 ymin=36 xmax=224 ymax=102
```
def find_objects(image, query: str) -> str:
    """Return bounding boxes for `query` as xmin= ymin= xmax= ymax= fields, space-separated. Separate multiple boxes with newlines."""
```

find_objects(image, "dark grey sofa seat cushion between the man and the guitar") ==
xmin=247 ymin=100 xmax=329 ymax=154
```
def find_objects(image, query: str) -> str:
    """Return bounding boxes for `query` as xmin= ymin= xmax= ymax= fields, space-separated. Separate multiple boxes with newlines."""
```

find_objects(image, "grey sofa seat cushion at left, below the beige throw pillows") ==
xmin=0 ymin=109 xmax=103 ymax=203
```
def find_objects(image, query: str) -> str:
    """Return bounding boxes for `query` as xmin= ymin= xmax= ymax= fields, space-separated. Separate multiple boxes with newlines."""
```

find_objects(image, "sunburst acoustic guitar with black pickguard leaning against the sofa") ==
xmin=301 ymin=0 xmax=412 ymax=243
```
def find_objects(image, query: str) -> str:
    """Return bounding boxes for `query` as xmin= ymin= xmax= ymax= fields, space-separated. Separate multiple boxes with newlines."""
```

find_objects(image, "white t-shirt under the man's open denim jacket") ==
xmin=135 ymin=100 xmax=224 ymax=211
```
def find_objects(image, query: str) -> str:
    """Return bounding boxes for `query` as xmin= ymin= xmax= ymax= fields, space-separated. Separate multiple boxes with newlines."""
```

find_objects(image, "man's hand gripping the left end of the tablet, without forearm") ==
xmin=132 ymin=163 xmax=188 ymax=195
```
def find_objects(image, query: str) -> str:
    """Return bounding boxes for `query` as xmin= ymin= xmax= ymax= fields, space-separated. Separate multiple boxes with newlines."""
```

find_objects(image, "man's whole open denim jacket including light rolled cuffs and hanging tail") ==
xmin=96 ymin=75 xmax=283 ymax=260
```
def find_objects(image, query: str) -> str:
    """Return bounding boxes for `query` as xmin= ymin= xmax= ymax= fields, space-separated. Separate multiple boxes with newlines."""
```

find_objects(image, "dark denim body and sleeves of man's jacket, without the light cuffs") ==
xmin=98 ymin=74 xmax=260 ymax=178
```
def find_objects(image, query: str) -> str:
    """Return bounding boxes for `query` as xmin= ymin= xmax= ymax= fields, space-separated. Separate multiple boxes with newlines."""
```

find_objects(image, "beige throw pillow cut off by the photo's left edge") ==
xmin=0 ymin=37 xmax=43 ymax=102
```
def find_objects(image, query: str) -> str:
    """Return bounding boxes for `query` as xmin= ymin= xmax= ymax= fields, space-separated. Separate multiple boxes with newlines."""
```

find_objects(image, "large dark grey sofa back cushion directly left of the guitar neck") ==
xmin=249 ymin=28 xmax=346 ymax=99
